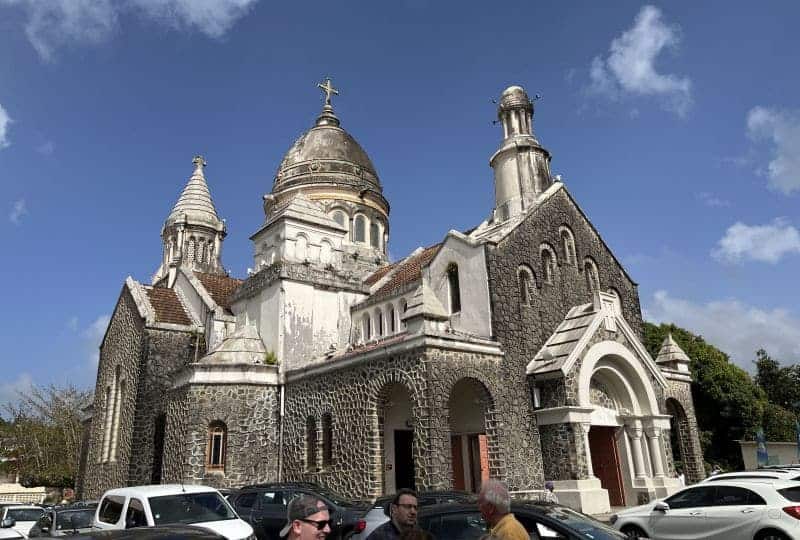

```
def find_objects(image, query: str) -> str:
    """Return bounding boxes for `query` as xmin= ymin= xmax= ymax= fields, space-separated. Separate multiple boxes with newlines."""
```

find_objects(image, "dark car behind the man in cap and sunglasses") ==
xmin=231 ymin=482 xmax=370 ymax=540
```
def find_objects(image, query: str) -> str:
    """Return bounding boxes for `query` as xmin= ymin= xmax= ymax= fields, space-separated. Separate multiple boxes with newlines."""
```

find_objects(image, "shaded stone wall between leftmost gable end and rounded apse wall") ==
xmin=128 ymin=329 xmax=200 ymax=485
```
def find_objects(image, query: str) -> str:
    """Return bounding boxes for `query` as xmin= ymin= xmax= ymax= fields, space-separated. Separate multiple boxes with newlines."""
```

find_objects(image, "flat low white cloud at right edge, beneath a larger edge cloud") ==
xmin=711 ymin=218 xmax=800 ymax=264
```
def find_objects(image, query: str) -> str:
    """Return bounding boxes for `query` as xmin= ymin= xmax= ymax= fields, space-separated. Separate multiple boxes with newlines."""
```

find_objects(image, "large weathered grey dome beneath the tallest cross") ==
xmin=272 ymin=106 xmax=382 ymax=193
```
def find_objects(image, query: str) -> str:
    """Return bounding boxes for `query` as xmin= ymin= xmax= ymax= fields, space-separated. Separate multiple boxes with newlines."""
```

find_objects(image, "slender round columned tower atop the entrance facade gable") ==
xmin=489 ymin=86 xmax=552 ymax=222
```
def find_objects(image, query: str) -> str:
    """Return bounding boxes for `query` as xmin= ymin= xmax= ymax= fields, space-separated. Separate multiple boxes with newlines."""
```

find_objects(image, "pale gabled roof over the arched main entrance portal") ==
xmin=526 ymin=292 xmax=667 ymax=387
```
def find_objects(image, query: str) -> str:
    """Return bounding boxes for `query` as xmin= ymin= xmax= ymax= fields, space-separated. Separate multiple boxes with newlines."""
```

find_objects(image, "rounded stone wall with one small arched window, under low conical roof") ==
xmin=164 ymin=384 xmax=279 ymax=488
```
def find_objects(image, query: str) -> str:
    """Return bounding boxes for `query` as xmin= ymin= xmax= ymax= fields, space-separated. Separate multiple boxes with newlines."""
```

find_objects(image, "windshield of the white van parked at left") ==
xmin=149 ymin=491 xmax=236 ymax=525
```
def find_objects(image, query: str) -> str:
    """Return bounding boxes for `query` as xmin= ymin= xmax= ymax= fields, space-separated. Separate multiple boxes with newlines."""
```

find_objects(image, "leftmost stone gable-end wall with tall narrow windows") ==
xmin=80 ymin=287 xmax=144 ymax=499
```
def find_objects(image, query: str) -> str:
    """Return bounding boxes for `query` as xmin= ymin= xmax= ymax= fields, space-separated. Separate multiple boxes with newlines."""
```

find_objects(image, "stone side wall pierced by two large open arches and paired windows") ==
xmin=284 ymin=347 xmax=542 ymax=497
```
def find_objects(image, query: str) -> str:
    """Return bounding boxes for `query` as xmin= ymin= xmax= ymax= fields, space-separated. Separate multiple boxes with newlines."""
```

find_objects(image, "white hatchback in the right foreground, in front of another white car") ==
xmin=610 ymin=480 xmax=800 ymax=540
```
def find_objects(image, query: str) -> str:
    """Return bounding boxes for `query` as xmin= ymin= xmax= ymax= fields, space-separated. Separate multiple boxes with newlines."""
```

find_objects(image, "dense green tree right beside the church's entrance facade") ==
xmin=644 ymin=323 xmax=795 ymax=468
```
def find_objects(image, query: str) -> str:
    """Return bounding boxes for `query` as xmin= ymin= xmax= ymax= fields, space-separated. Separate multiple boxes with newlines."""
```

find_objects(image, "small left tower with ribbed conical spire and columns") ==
xmin=153 ymin=156 xmax=227 ymax=286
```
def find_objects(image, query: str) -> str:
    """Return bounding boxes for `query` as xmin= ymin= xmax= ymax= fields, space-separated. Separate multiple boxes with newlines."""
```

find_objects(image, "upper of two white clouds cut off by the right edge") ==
xmin=747 ymin=107 xmax=800 ymax=195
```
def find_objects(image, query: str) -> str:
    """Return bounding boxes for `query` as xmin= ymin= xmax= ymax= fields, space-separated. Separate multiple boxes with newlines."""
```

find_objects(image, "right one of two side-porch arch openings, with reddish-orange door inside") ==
xmin=448 ymin=377 xmax=492 ymax=492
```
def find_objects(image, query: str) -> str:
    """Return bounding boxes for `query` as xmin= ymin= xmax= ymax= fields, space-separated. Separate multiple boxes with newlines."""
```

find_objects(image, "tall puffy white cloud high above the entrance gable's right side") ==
xmin=589 ymin=6 xmax=692 ymax=116
